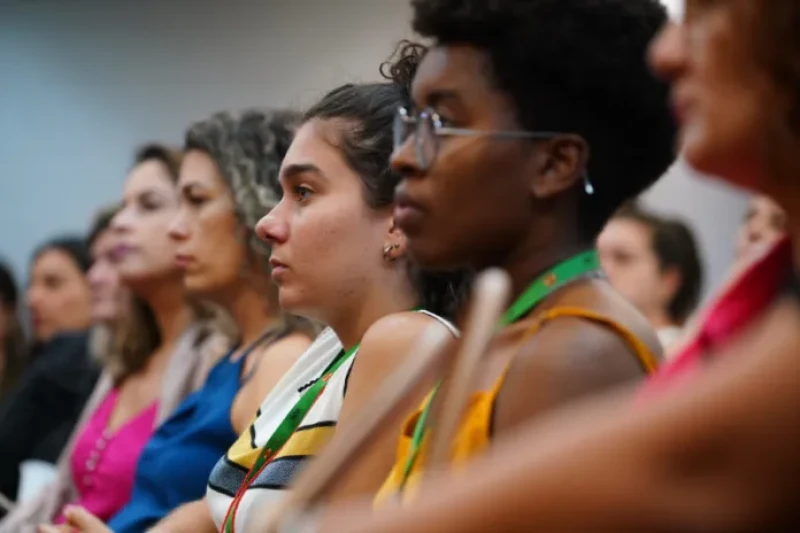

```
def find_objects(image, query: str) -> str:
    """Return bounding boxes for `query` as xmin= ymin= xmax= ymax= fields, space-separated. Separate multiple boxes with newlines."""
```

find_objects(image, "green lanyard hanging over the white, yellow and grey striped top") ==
xmin=220 ymin=344 xmax=359 ymax=533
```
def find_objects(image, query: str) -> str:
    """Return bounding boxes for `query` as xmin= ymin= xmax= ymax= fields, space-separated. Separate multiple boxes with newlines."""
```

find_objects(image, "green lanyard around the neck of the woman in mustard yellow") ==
xmin=400 ymin=250 xmax=600 ymax=490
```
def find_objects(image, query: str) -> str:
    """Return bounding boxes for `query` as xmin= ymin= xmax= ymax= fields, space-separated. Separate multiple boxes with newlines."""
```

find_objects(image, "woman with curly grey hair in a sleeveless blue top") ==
xmin=86 ymin=111 xmax=314 ymax=533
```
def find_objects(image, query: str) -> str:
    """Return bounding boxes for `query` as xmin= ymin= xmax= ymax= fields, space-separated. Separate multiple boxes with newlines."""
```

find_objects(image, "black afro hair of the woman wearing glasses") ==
xmin=412 ymin=0 xmax=675 ymax=238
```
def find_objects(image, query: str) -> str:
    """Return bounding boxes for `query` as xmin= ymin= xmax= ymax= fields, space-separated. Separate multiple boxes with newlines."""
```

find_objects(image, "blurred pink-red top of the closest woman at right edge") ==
xmin=640 ymin=238 xmax=792 ymax=399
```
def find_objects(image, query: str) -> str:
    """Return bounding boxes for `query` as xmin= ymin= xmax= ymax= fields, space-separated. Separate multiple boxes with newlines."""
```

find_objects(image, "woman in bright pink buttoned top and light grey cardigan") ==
xmin=0 ymin=149 xmax=228 ymax=533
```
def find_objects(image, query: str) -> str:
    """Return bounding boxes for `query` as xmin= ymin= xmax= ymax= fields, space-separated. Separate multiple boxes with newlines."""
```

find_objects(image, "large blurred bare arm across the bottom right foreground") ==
xmin=321 ymin=303 xmax=800 ymax=533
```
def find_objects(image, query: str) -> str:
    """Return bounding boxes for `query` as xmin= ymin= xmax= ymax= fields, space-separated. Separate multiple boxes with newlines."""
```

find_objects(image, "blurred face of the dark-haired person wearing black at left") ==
xmin=27 ymin=248 xmax=92 ymax=341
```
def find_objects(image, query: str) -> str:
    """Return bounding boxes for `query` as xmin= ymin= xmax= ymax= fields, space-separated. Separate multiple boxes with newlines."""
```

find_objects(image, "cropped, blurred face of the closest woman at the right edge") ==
xmin=650 ymin=0 xmax=797 ymax=197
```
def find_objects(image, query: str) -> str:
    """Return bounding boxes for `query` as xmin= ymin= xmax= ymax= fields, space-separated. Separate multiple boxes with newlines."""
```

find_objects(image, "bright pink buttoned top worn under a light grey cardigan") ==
xmin=56 ymin=388 xmax=158 ymax=523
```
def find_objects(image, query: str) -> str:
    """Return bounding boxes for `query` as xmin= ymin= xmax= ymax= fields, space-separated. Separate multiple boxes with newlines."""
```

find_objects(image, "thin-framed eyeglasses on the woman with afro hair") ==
xmin=394 ymin=107 xmax=560 ymax=170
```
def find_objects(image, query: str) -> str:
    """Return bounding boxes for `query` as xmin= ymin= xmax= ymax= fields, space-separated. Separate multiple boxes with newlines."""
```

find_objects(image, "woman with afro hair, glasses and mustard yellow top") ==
xmin=368 ymin=0 xmax=674 ymax=505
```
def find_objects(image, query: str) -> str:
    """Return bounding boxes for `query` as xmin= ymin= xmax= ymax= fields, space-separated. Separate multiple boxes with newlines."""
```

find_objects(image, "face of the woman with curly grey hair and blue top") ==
xmin=169 ymin=150 xmax=252 ymax=301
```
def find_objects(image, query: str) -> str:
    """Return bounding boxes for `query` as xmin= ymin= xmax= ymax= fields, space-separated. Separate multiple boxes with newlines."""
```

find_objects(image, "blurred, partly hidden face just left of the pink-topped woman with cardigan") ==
xmin=86 ymin=230 xmax=130 ymax=325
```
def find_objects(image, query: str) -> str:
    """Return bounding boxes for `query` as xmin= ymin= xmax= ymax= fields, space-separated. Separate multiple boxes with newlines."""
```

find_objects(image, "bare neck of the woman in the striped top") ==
xmin=324 ymin=264 xmax=419 ymax=350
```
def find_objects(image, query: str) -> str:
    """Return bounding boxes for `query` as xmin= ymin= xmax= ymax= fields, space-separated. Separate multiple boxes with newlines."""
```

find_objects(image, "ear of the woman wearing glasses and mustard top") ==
xmin=529 ymin=135 xmax=589 ymax=199
